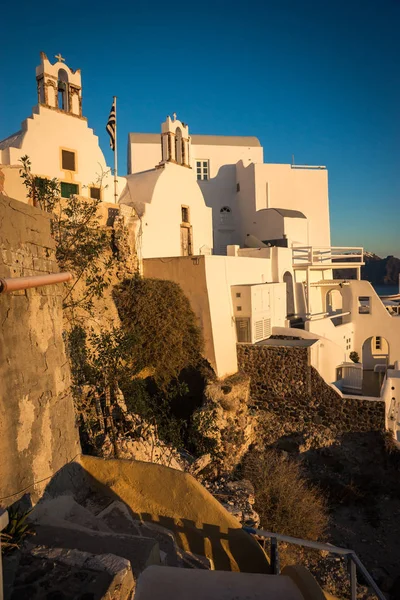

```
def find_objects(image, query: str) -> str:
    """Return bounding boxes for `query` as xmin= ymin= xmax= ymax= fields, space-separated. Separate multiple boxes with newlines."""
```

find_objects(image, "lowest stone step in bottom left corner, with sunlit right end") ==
xmin=3 ymin=544 xmax=135 ymax=600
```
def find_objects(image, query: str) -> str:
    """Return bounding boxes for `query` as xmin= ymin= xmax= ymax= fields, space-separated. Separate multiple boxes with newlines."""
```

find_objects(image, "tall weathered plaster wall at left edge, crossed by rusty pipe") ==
xmin=0 ymin=195 xmax=80 ymax=506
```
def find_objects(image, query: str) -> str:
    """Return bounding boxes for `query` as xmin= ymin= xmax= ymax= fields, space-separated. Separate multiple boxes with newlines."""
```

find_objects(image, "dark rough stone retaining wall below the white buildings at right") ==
xmin=237 ymin=344 xmax=385 ymax=434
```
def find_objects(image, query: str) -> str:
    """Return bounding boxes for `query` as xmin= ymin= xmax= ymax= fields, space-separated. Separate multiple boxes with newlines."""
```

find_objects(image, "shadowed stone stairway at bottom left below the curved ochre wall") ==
xmin=4 ymin=495 xmax=216 ymax=600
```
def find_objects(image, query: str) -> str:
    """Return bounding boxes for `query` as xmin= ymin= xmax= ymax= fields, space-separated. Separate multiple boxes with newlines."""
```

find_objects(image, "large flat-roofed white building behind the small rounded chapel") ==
xmin=128 ymin=132 xmax=330 ymax=254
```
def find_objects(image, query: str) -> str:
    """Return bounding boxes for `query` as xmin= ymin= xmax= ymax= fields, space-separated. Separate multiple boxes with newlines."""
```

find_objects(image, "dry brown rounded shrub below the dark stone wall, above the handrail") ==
xmin=244 ymin=450 xmax=328 ymax=540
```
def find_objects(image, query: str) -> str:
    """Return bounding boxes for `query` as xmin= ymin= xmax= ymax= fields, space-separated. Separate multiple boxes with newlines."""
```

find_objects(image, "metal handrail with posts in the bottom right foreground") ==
xmin=243 ymin=527 xmax=386 ymax=600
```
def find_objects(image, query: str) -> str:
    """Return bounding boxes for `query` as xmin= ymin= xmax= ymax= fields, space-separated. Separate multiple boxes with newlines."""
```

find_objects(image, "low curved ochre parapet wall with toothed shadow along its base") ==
xmin=44 ymin=456 xmax=269 ymax=573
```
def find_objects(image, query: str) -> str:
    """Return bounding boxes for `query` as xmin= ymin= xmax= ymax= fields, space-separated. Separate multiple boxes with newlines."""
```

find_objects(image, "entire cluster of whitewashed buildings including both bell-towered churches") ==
xmin=0 ymin=54 xmax=400 ymax=430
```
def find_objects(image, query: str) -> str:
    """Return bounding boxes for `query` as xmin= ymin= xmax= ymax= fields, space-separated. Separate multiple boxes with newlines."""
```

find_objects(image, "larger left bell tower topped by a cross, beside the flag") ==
xmin=36 ymin=52 xmax=82 ymax=117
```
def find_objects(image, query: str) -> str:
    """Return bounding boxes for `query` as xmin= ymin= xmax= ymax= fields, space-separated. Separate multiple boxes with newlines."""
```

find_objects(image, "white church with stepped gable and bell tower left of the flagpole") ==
xmin=0 ymin=52 xmax=122 ymax=203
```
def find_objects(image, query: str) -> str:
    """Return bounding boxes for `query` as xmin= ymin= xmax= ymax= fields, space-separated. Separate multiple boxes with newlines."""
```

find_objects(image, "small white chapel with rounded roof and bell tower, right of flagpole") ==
xmin=119 ymin=117 xmax=213 ymax=258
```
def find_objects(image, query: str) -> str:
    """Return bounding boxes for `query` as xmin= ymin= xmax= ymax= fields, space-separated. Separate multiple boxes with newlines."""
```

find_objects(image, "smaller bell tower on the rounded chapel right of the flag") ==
xmin=160 ymin=113 xmax=191 ymax=169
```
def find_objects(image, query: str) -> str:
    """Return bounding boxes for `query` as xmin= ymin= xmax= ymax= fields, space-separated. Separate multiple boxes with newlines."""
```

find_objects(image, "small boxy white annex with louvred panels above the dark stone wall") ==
xmin=231 ymin=283 xmax=286 ymax=344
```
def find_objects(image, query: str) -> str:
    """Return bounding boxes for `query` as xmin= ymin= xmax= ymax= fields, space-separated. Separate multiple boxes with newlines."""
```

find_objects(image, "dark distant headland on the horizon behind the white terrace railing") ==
xmin=334 ymin=252 xmax=400 ymax=286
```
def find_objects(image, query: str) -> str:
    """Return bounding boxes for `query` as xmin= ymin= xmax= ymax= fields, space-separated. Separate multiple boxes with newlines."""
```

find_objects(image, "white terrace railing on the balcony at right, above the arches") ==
xmin=292 ymin=246 xmax=364 ymax=269
